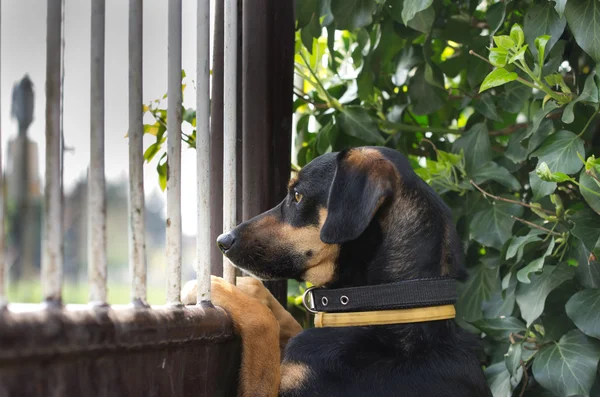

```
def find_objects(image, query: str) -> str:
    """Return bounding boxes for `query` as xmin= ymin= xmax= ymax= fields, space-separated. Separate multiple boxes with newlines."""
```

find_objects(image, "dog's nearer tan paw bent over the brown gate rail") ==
xmin=211 ymin=276 xmax=279 ymax=336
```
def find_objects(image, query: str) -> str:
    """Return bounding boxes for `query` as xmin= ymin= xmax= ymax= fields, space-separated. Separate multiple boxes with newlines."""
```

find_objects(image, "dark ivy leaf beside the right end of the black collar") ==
xmin=456 ymin=263 xmax=500 ymax=322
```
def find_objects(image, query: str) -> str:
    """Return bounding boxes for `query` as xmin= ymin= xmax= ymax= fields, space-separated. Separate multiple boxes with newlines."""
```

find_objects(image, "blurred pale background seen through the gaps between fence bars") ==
xmin=0 ymin=0 xmax=213 ymax=304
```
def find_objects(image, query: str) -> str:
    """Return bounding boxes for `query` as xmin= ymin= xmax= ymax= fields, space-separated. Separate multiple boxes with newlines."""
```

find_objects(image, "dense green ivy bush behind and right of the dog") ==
xmin=145 ymin=0 xmax=600 ymax=397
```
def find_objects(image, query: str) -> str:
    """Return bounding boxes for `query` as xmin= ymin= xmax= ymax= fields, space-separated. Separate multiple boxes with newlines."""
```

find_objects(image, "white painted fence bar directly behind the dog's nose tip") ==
xmin=223 ymin=0 xmax=238 ymax=283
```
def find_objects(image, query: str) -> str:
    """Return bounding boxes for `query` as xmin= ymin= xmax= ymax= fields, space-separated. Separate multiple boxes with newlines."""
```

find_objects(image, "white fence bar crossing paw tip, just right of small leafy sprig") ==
xmin=196 ymin=0 xmax=215 ymax=302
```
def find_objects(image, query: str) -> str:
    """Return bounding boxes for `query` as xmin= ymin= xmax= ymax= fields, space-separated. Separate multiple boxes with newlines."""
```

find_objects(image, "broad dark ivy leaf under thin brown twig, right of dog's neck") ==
xmin=470 ymin=201 xmax=523 ymax=250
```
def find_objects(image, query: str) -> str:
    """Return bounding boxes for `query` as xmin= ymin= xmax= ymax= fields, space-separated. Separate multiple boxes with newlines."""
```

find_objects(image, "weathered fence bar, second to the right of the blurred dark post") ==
xmin=88 ymin=0 xmax=106 ymax=305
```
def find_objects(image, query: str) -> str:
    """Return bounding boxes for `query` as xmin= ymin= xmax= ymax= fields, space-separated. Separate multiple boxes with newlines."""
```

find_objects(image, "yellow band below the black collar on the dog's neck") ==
xmin=315 ymin=305 xmax=456 ymax=328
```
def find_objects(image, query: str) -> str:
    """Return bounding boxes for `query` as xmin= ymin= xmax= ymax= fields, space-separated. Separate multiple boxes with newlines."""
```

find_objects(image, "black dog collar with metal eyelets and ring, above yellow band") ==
xmin=302 ymin=277 xmax=457 ymax=313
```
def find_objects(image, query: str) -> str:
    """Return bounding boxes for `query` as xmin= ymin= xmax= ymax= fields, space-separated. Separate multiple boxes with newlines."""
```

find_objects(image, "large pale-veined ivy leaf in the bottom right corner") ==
xmin=533 ymin=330 xmax=600 ymax=397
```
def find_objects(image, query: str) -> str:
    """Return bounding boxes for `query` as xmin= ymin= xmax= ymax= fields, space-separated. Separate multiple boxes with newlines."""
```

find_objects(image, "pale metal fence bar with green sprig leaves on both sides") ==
xmin=167 ymin=0 xmax=182 ymax=305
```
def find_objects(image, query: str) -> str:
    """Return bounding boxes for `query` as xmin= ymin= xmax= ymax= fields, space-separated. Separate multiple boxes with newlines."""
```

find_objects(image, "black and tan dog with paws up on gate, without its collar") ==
xmin=182 ymin=147 xmax=491 ymax=397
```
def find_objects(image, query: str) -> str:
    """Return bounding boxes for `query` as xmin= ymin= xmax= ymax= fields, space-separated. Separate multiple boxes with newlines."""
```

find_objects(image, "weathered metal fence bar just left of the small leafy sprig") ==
xmin=128 ymin=0 xmax=147 ymax=306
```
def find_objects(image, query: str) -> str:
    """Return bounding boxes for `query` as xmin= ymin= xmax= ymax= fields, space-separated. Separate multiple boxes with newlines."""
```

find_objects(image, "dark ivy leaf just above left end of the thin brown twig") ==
xmin=452 ymin=123 xmax=492 ymax=174
